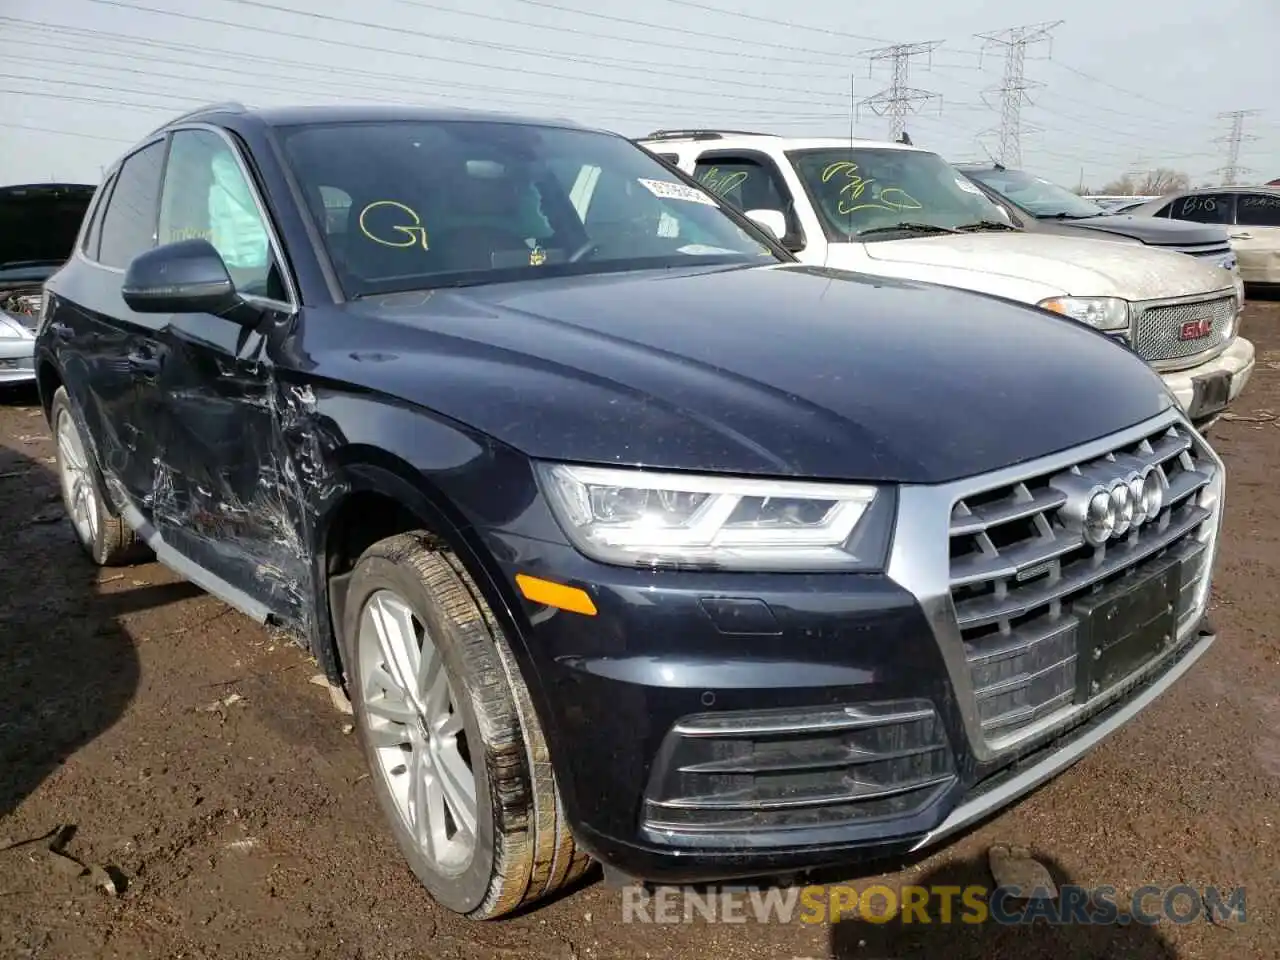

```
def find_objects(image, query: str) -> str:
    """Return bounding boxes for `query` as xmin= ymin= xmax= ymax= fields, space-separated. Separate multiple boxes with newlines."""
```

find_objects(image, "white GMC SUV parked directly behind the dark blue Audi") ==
xmin=637 ymin=131 xmax=1254 ymax=426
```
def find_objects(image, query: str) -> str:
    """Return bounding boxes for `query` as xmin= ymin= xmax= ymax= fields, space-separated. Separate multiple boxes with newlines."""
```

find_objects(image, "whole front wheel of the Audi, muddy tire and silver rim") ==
xmin=342 ymin=534 xmax=589 ymax=919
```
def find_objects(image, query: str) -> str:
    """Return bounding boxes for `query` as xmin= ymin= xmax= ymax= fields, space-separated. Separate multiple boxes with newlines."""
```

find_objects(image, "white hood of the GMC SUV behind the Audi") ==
xmin=865 ymin=230 xmax=1233 ymax=300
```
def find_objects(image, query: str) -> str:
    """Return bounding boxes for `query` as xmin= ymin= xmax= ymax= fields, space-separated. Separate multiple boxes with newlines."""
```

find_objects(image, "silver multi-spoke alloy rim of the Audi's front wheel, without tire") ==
xmin=356 ymin=590 xmax=476 ymax=873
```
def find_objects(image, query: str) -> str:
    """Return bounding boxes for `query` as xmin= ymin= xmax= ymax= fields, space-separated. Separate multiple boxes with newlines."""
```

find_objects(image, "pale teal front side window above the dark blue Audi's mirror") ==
xmin=159 ymin=131 xmax=284 ymax=300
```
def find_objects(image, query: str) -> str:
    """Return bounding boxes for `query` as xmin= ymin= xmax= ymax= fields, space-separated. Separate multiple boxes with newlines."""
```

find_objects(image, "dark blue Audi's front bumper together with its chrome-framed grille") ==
xmin=490 ymin=408 xmax=1224 ymax=882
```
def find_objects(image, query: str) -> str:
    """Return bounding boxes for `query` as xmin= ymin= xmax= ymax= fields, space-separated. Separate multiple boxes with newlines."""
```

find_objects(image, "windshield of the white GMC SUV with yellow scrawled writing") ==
xmin=788 ymin=147 xmax=1009 ymax=243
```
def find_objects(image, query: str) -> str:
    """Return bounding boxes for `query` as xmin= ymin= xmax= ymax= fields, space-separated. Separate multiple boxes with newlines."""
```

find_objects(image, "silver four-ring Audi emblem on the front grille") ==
xmin=1052 ymin=463 xmax=1165 ymax=547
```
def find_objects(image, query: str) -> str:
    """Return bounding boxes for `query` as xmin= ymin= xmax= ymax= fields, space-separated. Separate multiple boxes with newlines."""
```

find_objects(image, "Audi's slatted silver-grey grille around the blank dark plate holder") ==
xmin=950 ymin=422 xmax=1219 ymax=750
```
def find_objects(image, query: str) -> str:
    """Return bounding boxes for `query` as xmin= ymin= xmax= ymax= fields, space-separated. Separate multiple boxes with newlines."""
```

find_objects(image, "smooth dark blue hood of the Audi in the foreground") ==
xmin=330 ymin=265 xmax=1171 ymax=483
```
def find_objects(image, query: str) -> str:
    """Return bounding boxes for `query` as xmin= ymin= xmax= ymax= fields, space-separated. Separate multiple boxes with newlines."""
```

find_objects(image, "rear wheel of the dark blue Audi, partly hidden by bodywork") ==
xmin=50 ymin=387 xmax=148 ymax=567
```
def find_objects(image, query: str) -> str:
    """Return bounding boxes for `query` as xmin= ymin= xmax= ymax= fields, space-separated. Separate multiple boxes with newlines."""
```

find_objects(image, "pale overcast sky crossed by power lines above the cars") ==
xmin=0 ymin=0 xmax=1280 ymax=188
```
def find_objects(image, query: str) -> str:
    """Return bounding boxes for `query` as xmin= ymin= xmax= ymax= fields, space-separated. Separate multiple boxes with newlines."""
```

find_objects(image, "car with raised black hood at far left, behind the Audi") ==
xmin=0 ymin=183 xmax=97 ymax=388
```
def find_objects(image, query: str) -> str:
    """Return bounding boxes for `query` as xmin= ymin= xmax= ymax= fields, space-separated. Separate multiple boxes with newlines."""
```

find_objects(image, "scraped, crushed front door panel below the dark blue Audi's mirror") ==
xmin=126 ymin=314 xmax=348 ymax=649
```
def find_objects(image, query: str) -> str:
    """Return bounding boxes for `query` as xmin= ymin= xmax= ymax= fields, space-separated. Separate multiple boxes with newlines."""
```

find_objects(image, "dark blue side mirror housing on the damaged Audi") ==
xmin=122 ymin=239 xmax=243 ymax=315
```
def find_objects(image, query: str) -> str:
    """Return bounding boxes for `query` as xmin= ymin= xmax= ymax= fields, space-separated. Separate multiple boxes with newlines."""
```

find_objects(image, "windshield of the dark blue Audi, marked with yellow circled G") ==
xmin=282 ymin=120 xmax=778 ymax=297
